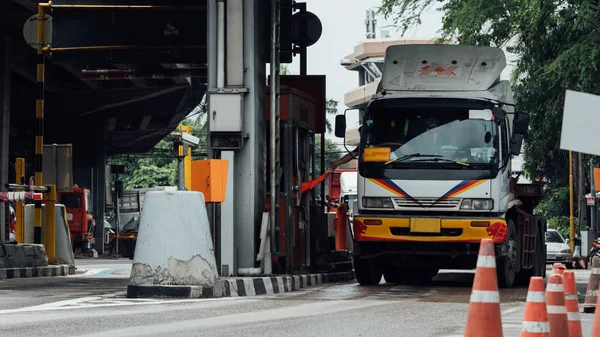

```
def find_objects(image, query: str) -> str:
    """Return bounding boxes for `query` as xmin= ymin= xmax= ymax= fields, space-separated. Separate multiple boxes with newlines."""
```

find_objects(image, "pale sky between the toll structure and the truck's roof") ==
xmin=288 ymin=0 xmax=442 ymax=143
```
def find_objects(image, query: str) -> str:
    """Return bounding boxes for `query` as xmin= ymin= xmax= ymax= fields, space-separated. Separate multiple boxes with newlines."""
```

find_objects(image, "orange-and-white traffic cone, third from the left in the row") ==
xmin=546 ymin=274 xmax=569 ymax=337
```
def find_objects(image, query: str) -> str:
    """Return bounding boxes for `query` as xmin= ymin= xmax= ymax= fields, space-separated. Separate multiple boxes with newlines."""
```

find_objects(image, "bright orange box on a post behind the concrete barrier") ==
xmin=191 ymin=159 xmax=229 ymax=202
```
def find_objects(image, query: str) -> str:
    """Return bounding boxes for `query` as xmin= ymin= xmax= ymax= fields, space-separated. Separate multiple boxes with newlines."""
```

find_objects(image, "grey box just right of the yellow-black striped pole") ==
xmin=42 ymin=144 xmax=73 ymax=192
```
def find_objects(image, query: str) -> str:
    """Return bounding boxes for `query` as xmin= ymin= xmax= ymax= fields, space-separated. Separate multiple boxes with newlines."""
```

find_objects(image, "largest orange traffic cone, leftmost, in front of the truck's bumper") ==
xmin=465 ymin=239 xmax=503 ymax=337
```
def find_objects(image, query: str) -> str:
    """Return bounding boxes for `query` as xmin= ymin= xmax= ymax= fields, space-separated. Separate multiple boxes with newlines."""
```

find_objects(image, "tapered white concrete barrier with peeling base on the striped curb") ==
xmin=130 ymin=189 xmax=218 ymax=292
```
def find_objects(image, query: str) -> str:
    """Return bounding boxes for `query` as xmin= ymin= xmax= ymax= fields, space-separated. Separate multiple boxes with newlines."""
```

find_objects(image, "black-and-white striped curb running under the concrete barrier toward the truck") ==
xmin=127 ymin=271 xmax=354 ymax=298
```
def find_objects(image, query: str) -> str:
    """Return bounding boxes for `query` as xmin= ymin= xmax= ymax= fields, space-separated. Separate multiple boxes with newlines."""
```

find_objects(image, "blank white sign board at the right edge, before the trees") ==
xmin=560 ymin=90 xmax=600 ymax=156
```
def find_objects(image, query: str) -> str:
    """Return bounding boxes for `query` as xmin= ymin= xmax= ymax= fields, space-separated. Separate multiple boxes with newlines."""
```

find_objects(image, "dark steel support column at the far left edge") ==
xmin=0 ymin=35 xmax=11 ymax=244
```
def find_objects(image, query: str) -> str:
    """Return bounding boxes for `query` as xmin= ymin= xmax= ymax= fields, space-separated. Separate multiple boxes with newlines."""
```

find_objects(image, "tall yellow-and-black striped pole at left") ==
xmin=33 ymin=5 xmax=46 ymax=244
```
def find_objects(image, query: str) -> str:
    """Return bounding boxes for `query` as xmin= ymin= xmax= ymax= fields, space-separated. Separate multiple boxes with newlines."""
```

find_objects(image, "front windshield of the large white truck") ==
xmin=361 ymin=106 xmax=500 ymax=165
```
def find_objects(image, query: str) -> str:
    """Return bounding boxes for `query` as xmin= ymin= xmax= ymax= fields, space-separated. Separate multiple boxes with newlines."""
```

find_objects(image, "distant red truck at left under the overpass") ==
xmin=58 ymin=185 xmax=96 ymax=253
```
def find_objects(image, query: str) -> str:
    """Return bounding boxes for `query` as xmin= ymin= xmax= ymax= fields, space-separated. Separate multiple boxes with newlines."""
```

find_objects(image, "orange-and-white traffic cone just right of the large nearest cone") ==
xmin=521 ymin=276 xmax=550 ymax=337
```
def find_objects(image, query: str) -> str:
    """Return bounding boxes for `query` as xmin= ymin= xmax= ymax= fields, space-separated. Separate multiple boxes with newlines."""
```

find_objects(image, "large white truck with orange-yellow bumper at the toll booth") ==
xmin=335 ymin=45 xmax=546 ymax=287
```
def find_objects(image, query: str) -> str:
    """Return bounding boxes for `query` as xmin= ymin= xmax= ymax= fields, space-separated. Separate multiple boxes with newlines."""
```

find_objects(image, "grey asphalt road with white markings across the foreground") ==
xmin=0 ymin=261 xmax=592 ymax=337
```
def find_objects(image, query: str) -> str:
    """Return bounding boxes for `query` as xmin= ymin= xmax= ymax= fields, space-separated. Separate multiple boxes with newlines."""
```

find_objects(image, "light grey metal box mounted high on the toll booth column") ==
xmin=208 ymin=92 xmax=244 ymax=133
